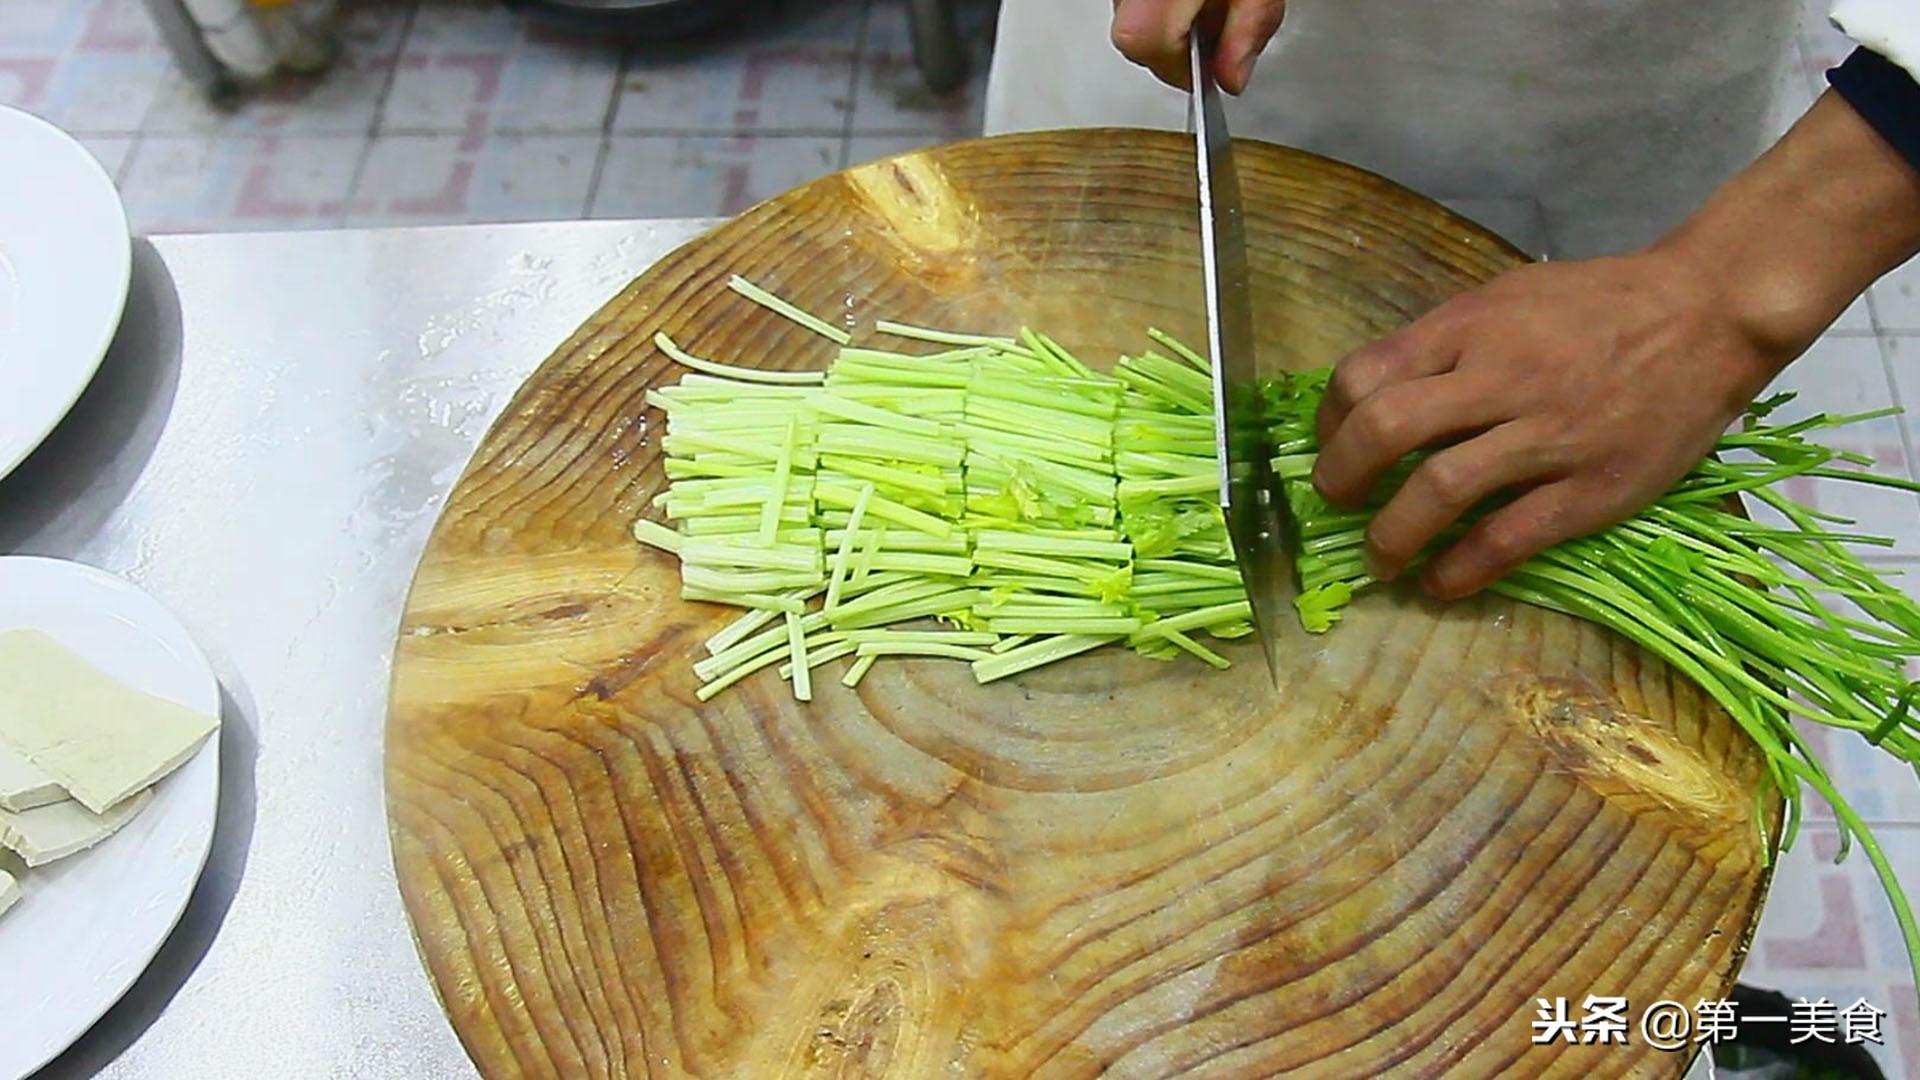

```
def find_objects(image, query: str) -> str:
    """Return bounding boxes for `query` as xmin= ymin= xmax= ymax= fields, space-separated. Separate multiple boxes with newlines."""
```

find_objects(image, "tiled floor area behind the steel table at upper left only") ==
xmin=0 ymin=0 xmax=995 ymax=233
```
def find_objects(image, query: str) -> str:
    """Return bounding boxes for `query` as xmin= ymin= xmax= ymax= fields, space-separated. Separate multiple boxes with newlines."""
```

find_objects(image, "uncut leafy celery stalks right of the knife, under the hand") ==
xmin=1265 ymin=371 xmax=1920 ymax=978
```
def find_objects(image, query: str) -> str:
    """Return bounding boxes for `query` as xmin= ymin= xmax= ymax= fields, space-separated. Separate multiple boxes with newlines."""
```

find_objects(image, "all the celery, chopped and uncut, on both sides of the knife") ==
xmin=634 ymin=277 xmax=1920 ymax=978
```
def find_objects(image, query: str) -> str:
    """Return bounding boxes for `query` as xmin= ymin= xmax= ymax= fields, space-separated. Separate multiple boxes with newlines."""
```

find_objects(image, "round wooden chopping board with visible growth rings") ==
xmin=386 ymin=131 xmax=1778 ymax=1080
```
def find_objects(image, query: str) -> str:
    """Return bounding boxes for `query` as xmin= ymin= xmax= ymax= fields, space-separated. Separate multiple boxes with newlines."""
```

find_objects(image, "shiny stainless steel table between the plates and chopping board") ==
xmin=0 ymin=221 xmax=707 ymax=1080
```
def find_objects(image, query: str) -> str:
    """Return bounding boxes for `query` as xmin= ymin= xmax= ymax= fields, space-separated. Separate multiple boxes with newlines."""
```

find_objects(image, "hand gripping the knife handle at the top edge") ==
xmin=1114 ymin=0 xmax=1286 ymax=94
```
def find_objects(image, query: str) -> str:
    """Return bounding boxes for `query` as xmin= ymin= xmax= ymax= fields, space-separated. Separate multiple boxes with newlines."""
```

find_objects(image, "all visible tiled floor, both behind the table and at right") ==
xmin=0 ymin=0 xmax=1920 ymax=1076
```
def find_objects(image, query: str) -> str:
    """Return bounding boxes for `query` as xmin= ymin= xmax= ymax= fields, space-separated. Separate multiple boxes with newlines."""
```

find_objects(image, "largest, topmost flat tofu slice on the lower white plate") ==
xmin=0 ymin=630 xmax=219 ymax=813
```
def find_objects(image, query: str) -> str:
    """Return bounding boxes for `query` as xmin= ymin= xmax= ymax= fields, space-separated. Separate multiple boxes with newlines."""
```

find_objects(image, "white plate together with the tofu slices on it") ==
xmin=0 ymin=557 xmax=221 ymax=1080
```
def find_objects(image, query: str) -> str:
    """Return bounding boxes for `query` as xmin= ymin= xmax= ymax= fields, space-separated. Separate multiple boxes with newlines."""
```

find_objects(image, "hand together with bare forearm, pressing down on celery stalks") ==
xmin=1313 ymin=92 xmax=1920 ymax=598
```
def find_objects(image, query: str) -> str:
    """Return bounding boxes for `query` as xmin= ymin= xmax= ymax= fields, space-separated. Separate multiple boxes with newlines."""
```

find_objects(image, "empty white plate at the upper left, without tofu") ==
xmin=0 ymin=106 xmax=132 ymax=477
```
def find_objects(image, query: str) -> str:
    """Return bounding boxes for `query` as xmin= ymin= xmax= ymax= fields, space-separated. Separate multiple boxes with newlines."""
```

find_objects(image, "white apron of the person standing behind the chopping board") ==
xmin=987 ymin=0 xmax=1799 ymax=258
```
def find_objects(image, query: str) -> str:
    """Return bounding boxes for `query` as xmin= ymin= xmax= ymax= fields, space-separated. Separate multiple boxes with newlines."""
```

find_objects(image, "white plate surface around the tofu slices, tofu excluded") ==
xmin=0 ymin=557 xmax=221 ymax=1080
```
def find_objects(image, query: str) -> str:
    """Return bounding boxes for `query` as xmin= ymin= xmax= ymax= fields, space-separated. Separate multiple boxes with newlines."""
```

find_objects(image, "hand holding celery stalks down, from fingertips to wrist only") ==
xmin=1313 ymin=252 xmax=1786 ymax=598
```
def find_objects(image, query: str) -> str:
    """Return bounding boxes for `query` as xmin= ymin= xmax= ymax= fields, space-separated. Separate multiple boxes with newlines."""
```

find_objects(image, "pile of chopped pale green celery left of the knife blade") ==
xmin=634 ymin=277 xmax=1252 ymax=701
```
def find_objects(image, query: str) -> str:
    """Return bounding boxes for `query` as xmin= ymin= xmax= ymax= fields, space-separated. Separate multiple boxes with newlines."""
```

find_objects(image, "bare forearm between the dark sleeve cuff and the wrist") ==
xmin=1655 ymin=92 xmax=1920 ymax=365
